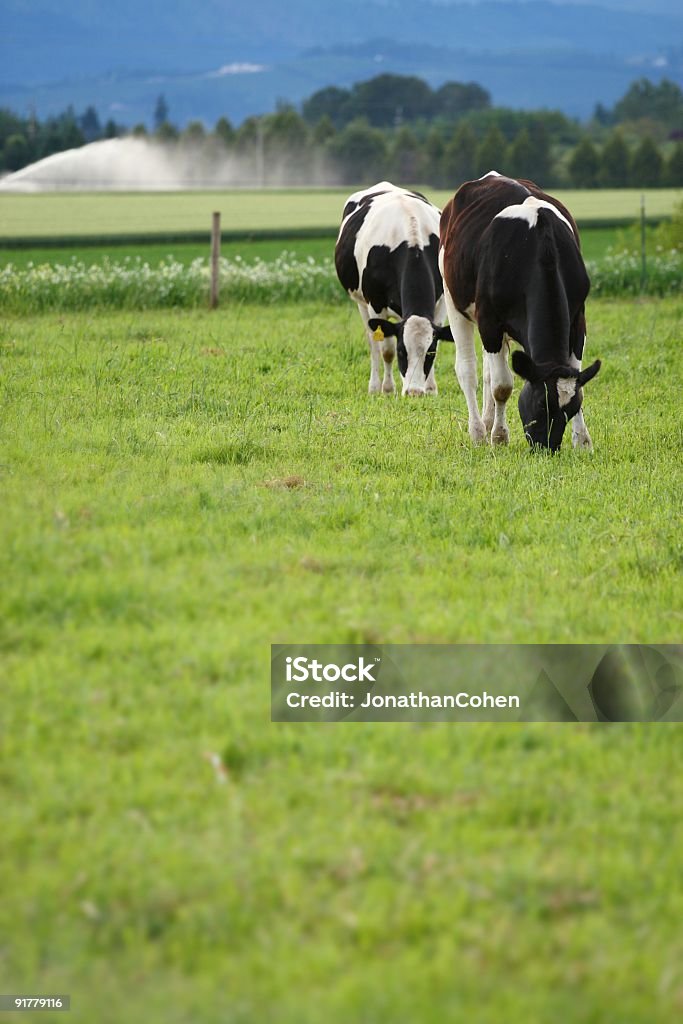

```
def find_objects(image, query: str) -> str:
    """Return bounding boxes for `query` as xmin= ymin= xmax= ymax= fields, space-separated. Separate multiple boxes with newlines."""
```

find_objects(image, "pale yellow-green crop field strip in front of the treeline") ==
xmin=0 ymin=187 xmax=681 ymax=244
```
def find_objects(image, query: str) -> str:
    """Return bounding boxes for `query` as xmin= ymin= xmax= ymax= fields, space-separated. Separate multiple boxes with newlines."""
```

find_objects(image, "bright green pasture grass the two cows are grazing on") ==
xmin=0 ymin=300 xmax=683 ymax=1024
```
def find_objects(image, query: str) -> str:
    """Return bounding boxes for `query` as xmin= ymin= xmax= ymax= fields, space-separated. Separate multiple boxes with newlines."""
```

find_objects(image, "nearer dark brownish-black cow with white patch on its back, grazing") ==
xmin=439 ymin=171 xmax=600 ymax=452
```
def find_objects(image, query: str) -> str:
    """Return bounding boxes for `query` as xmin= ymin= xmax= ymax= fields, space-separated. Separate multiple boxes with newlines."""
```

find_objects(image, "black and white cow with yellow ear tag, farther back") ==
xmin=335 ymin=181 xmax=453 ymax=395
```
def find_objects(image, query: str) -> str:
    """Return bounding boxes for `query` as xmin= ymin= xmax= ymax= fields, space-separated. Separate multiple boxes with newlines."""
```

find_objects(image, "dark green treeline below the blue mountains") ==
xmin=0 ymin=75 xmax=683 ymax=188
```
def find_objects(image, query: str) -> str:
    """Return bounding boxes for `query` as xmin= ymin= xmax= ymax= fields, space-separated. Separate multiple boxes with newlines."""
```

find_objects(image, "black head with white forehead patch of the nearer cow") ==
xmin=512 ymin=351 xmax=600 ymax=452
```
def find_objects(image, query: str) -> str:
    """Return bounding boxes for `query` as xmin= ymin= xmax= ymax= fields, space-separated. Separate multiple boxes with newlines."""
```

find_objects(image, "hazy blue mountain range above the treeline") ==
xmin=0 ymin=0 xmax=683 ymax=126
